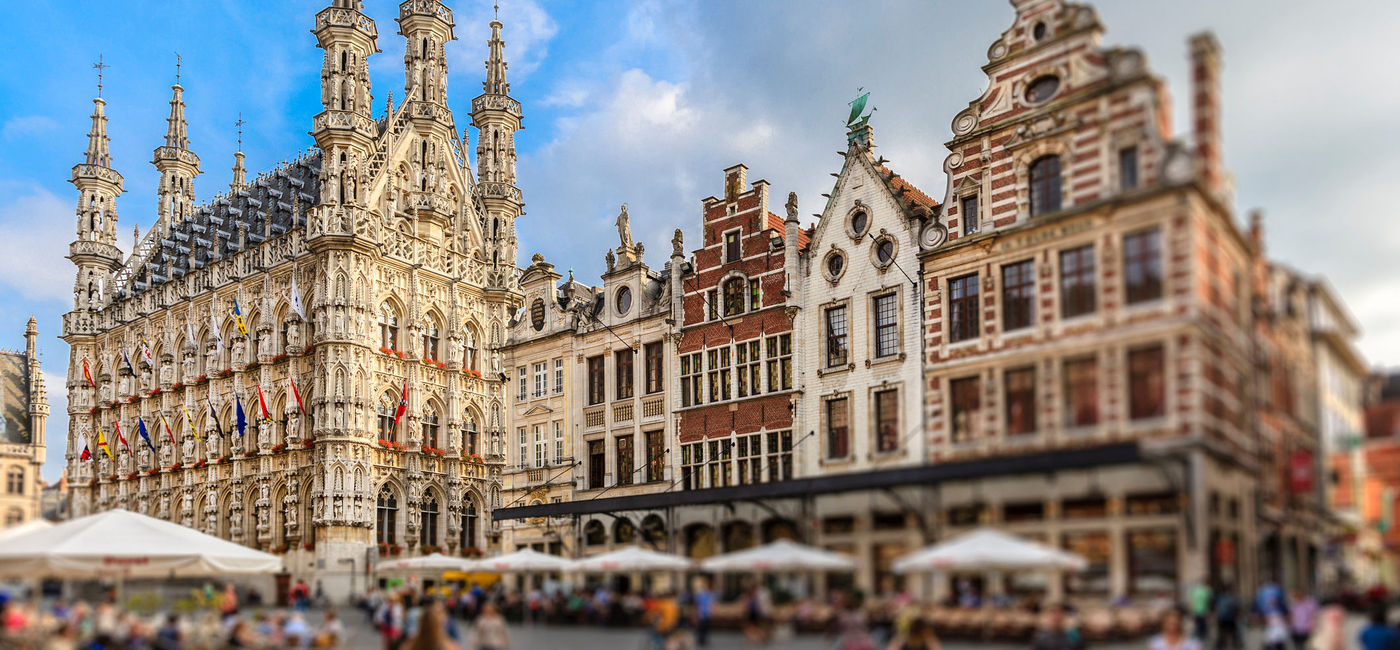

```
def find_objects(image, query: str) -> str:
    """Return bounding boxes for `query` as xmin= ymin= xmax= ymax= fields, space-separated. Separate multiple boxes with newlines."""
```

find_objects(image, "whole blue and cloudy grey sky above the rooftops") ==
xmin=0 ymin=0 xmax=1400 ymax=479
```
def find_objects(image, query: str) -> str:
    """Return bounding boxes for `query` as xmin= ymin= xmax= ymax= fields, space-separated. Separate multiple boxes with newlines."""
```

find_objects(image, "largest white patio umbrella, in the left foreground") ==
xmin=0 ymin=510 xmax=281 ymax=577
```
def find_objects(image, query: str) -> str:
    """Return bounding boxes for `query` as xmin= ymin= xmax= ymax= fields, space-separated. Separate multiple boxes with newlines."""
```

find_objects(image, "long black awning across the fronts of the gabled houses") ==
xmin=491 ymin=443 xmax=1142 ymax=521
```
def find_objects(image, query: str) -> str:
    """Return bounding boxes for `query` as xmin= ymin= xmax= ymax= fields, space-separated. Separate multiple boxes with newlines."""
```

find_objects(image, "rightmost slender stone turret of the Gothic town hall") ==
xmin=472 ymin=13 xmax=525 ymax=277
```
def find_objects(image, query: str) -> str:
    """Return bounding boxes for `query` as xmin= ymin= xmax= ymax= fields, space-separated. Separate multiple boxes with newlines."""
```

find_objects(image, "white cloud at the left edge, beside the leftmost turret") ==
xmin=0 ymin=182 xmax=77 ymax=301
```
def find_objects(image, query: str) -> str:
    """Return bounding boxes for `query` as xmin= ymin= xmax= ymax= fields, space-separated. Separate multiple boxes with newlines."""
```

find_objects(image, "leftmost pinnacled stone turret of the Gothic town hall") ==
xmin=69 ymin=62 xmax=125 ymax=311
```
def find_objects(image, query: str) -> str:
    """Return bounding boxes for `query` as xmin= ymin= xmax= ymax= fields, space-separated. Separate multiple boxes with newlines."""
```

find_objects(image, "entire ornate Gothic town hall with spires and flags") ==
xmin=63 ymin=0 xmax=522 ymax=595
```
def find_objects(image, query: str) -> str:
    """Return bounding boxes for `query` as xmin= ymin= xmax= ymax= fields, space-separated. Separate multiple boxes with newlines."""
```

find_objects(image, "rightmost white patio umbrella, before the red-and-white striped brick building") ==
xmin=893 ymin=528 xmax=1088 ymax=573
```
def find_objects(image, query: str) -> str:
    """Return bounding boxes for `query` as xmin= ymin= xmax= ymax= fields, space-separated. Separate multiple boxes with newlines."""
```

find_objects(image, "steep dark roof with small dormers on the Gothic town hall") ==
xmin=116 ymin=151 xmax=321 ymax=298
